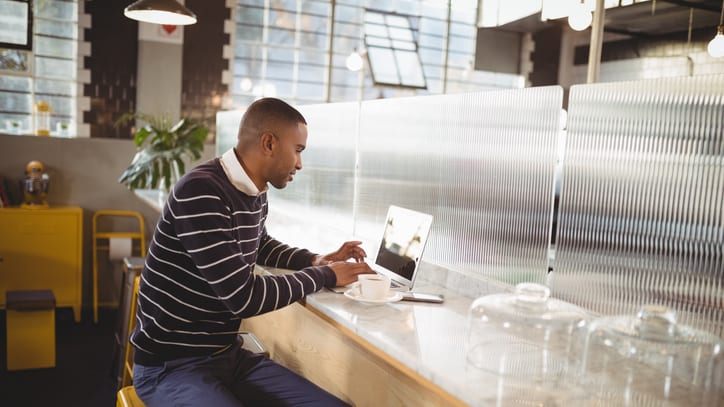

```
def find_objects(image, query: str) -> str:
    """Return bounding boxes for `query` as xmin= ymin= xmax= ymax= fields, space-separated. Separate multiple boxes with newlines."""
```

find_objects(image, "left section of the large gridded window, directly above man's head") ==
xmin=231 ymin=0 xmax=332 ymax=106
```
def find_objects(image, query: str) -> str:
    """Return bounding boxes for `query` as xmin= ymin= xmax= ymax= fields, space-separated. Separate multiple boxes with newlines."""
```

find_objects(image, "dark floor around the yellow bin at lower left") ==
xmin=0 ymin=308 xmax=116 ymax=407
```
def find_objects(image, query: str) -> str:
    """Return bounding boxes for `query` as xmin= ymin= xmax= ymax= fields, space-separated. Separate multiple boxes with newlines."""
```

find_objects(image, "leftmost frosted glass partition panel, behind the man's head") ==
xmin=216 ymin=102 xmax=359 ymax=251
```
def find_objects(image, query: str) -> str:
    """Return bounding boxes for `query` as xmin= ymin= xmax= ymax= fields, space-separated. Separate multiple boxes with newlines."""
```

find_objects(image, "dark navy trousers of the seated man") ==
xmin=133 ymin=346 xmax=348 ymax=407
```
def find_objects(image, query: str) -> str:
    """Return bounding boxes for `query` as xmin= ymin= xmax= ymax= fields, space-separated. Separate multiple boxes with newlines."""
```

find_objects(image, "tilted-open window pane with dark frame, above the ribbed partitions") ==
xmin=364 ymin=10 xmax=427 ymax=89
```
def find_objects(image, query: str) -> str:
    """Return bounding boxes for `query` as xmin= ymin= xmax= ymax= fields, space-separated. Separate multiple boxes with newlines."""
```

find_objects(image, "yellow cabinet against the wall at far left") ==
xmin=0 ymin=207 xmax=83 ymax=322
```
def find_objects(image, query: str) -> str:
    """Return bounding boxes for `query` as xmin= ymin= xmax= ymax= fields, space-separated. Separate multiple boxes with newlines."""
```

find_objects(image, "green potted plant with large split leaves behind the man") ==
xmin=116 ymin=112 xmax=209 ymax=191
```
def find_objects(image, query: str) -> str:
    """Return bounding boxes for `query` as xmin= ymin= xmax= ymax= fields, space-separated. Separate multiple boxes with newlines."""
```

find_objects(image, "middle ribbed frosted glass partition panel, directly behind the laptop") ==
xmin=355 ymin=86 xmax=563 ymax=284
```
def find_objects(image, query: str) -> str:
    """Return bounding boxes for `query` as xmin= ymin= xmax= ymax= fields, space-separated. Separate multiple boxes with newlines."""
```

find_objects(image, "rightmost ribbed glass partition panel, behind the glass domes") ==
xmin=552 ymin=75 xmax=724 ymax=336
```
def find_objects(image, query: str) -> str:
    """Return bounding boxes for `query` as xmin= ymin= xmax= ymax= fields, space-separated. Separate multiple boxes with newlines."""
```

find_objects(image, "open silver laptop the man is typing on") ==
xmin=333 ymin=205 xmax=432 ymax=293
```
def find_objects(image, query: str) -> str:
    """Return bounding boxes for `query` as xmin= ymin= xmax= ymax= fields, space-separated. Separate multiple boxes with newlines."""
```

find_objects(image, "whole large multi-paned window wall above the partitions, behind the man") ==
xmin=229 ymin=0 xmax=524 ymax=108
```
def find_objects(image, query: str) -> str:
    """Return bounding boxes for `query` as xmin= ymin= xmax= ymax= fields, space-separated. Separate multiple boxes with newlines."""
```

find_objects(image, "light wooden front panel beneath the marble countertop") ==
xmin=242 ymin=303 xmax=466 ymax=406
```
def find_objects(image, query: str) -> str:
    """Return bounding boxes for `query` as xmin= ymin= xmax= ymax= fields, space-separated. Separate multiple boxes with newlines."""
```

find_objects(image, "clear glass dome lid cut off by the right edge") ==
xmin=581 ymin=305 xmax=724 ymax=406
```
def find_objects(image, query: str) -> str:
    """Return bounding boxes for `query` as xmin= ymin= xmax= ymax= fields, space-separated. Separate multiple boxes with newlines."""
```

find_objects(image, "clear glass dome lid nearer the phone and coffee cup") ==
xmin=467 ymin=283 xmax=589 ymax=381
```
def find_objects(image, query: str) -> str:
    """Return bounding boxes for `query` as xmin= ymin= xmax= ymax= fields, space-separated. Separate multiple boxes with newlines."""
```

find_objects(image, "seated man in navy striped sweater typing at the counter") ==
xmin=130 ymin=98 xmax=372 ymax=407
